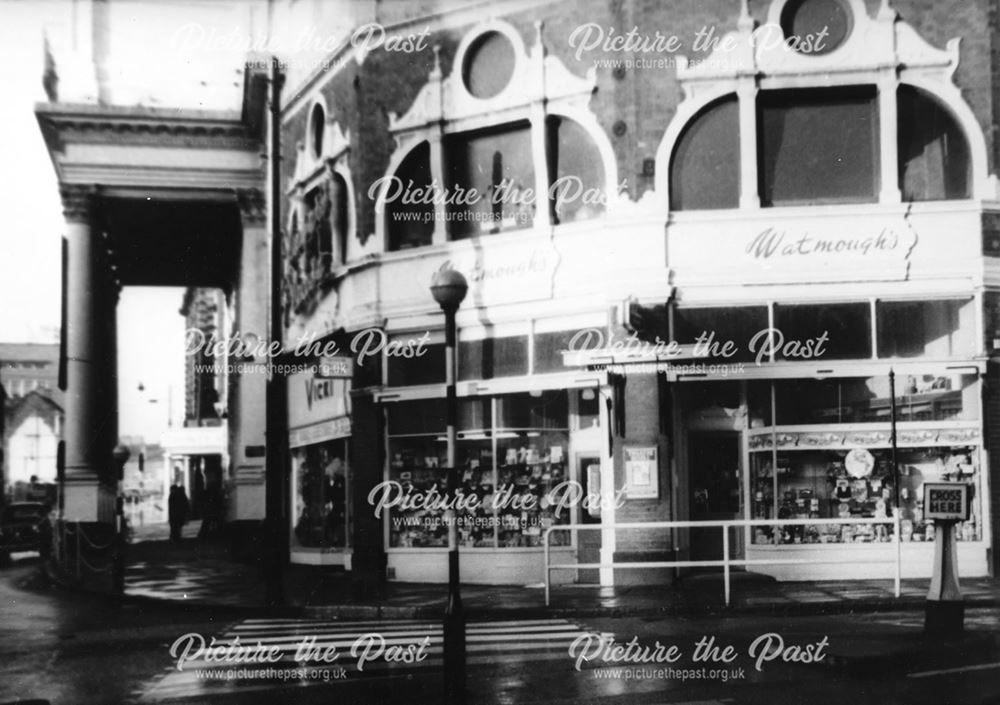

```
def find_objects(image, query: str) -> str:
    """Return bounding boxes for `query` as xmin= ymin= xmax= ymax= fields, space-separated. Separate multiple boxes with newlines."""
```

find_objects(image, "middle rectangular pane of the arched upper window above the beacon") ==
xmin=444 ymin=123 xmax=538 ymax=240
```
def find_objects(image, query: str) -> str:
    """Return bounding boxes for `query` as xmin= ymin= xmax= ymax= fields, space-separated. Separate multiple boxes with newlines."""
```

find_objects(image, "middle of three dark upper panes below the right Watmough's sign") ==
xmin=757 ymin=303 xmax=872 ymax=361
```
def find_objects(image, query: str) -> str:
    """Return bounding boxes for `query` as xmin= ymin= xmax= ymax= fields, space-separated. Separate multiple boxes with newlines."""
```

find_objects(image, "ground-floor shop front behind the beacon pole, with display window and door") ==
xmin=370 ymin=321 xmax=606 ymax=584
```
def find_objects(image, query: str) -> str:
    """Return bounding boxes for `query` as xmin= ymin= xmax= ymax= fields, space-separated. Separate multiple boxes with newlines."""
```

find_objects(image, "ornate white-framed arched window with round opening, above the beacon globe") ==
xmin=375 ymin=20 xmax=617 ymax=251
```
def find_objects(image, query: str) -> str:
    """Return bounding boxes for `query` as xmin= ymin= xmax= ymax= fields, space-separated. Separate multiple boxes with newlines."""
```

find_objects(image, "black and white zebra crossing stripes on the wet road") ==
xmin=138 ymin=619 xmax=589 ymax=702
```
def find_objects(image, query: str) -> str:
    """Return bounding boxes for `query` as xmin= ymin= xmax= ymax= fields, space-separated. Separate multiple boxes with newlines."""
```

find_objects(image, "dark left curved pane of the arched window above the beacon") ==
xmin=385 ymin=142 xmax=434 ymax=251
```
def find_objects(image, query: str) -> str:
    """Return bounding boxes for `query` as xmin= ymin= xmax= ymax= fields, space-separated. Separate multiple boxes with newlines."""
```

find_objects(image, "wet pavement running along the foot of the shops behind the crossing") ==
xmin=101 ymin=525 xmax=1000 ymax=619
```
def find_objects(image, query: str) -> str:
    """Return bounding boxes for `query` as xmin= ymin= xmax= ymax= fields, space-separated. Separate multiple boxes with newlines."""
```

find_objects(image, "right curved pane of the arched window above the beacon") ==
xmin=547 ymin=116 xmax=613 ymax=223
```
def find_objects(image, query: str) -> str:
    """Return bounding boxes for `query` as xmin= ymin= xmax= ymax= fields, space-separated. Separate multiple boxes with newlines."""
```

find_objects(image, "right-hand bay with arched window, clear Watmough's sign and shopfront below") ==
xmin=644 ymin=0 xmax=998 ymax=580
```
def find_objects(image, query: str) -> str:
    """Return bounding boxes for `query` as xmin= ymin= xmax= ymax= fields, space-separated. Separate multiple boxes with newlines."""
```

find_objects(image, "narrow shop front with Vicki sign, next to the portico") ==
xmin=288 ymin=365 xmax=351 ymax=569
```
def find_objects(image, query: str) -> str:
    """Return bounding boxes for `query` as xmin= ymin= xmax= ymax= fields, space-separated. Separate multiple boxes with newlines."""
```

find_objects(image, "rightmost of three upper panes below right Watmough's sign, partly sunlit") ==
xmin=875 ymin=299 xmax=976 ymax=358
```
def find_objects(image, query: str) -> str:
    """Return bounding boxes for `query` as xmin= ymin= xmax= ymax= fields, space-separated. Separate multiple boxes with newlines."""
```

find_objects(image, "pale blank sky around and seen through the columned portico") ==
xmin=0 ymin=0 xmax=260 ymax=440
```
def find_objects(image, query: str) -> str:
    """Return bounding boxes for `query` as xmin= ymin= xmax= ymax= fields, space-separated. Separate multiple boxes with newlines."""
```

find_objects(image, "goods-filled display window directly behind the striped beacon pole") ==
xmin=387 ymin=391 xmax=573 ymax=548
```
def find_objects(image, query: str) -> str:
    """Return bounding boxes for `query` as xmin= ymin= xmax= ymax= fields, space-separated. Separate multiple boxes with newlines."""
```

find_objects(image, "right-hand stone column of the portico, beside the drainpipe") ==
xmin=229 ymin=189 xmax=270 ymax=521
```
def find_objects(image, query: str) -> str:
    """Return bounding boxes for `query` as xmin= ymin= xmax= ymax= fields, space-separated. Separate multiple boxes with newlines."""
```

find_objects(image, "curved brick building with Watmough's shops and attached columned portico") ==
xmin=38 ymin=0 xmax=1000 ymax=584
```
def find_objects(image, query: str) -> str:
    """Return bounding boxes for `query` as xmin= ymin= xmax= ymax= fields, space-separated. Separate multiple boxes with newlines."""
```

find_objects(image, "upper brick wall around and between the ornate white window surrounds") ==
xmin=283 ymin=0 xmax=996 ymax=250
